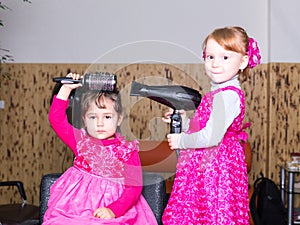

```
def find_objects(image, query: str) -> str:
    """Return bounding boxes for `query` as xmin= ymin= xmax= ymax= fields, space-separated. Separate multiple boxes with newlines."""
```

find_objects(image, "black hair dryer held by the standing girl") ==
xmin=130 ymin=81 xmax=201 ymax=156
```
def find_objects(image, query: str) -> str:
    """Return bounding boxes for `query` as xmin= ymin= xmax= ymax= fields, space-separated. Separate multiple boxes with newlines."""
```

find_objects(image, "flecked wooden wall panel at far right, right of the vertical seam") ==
xmin=267 ymin=63 xmax=300 ymax=181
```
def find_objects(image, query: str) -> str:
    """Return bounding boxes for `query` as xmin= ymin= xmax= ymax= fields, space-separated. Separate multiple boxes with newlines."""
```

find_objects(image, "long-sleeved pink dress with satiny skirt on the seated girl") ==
xmin=43 ymin=98 xmax=157 ymax=225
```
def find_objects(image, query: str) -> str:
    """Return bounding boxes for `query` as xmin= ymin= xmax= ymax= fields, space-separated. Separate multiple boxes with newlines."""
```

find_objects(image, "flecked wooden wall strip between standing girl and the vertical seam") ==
xmin=242 ymin=65 xmax=269 ymax=183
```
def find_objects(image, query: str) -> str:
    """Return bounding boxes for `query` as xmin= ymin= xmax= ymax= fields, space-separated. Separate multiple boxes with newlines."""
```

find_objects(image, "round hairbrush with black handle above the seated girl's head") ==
xmin=53 ymin=72 xmax=117 ymax=91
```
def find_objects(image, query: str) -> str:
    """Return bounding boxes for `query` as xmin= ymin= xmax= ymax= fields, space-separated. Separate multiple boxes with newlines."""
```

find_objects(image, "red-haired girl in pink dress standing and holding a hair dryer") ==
xmin=163 ymin=27 xmax=260 ymax=225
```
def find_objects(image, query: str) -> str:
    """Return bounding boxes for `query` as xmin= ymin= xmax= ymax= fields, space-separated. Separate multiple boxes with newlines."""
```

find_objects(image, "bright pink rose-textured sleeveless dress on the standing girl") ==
xmin=163 ymin=86 xmax=249 ymax=225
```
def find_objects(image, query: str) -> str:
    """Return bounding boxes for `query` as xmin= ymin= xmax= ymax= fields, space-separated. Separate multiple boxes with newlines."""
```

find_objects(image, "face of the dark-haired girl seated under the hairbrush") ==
xmin=83 ymin=98 xmax=123 ymax=139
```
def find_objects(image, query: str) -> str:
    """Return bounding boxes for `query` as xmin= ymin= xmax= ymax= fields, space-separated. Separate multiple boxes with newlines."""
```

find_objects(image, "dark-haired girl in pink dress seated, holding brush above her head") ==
xmin=43 ymin=74 xmax=157 ymax=225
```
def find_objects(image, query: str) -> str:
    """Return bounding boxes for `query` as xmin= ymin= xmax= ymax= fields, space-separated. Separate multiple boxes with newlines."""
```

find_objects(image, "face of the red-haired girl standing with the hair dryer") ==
xmin=205 ymin=38 xmax=248 ymax=83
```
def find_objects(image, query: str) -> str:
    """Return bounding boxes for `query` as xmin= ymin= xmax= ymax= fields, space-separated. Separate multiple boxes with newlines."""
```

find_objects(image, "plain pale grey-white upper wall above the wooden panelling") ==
xmin=0 ymin=0 xmax=300 ymax=63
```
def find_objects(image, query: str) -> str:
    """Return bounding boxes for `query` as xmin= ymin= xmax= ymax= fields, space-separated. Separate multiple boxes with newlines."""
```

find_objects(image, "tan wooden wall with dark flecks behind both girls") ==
xmin=0 ymin=63 xmax=300 ymax=205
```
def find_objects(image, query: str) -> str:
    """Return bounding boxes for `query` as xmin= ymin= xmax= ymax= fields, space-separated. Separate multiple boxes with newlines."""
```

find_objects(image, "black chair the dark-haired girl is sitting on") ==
xmin=40 ymin=172 xmax=167 ymax=225
